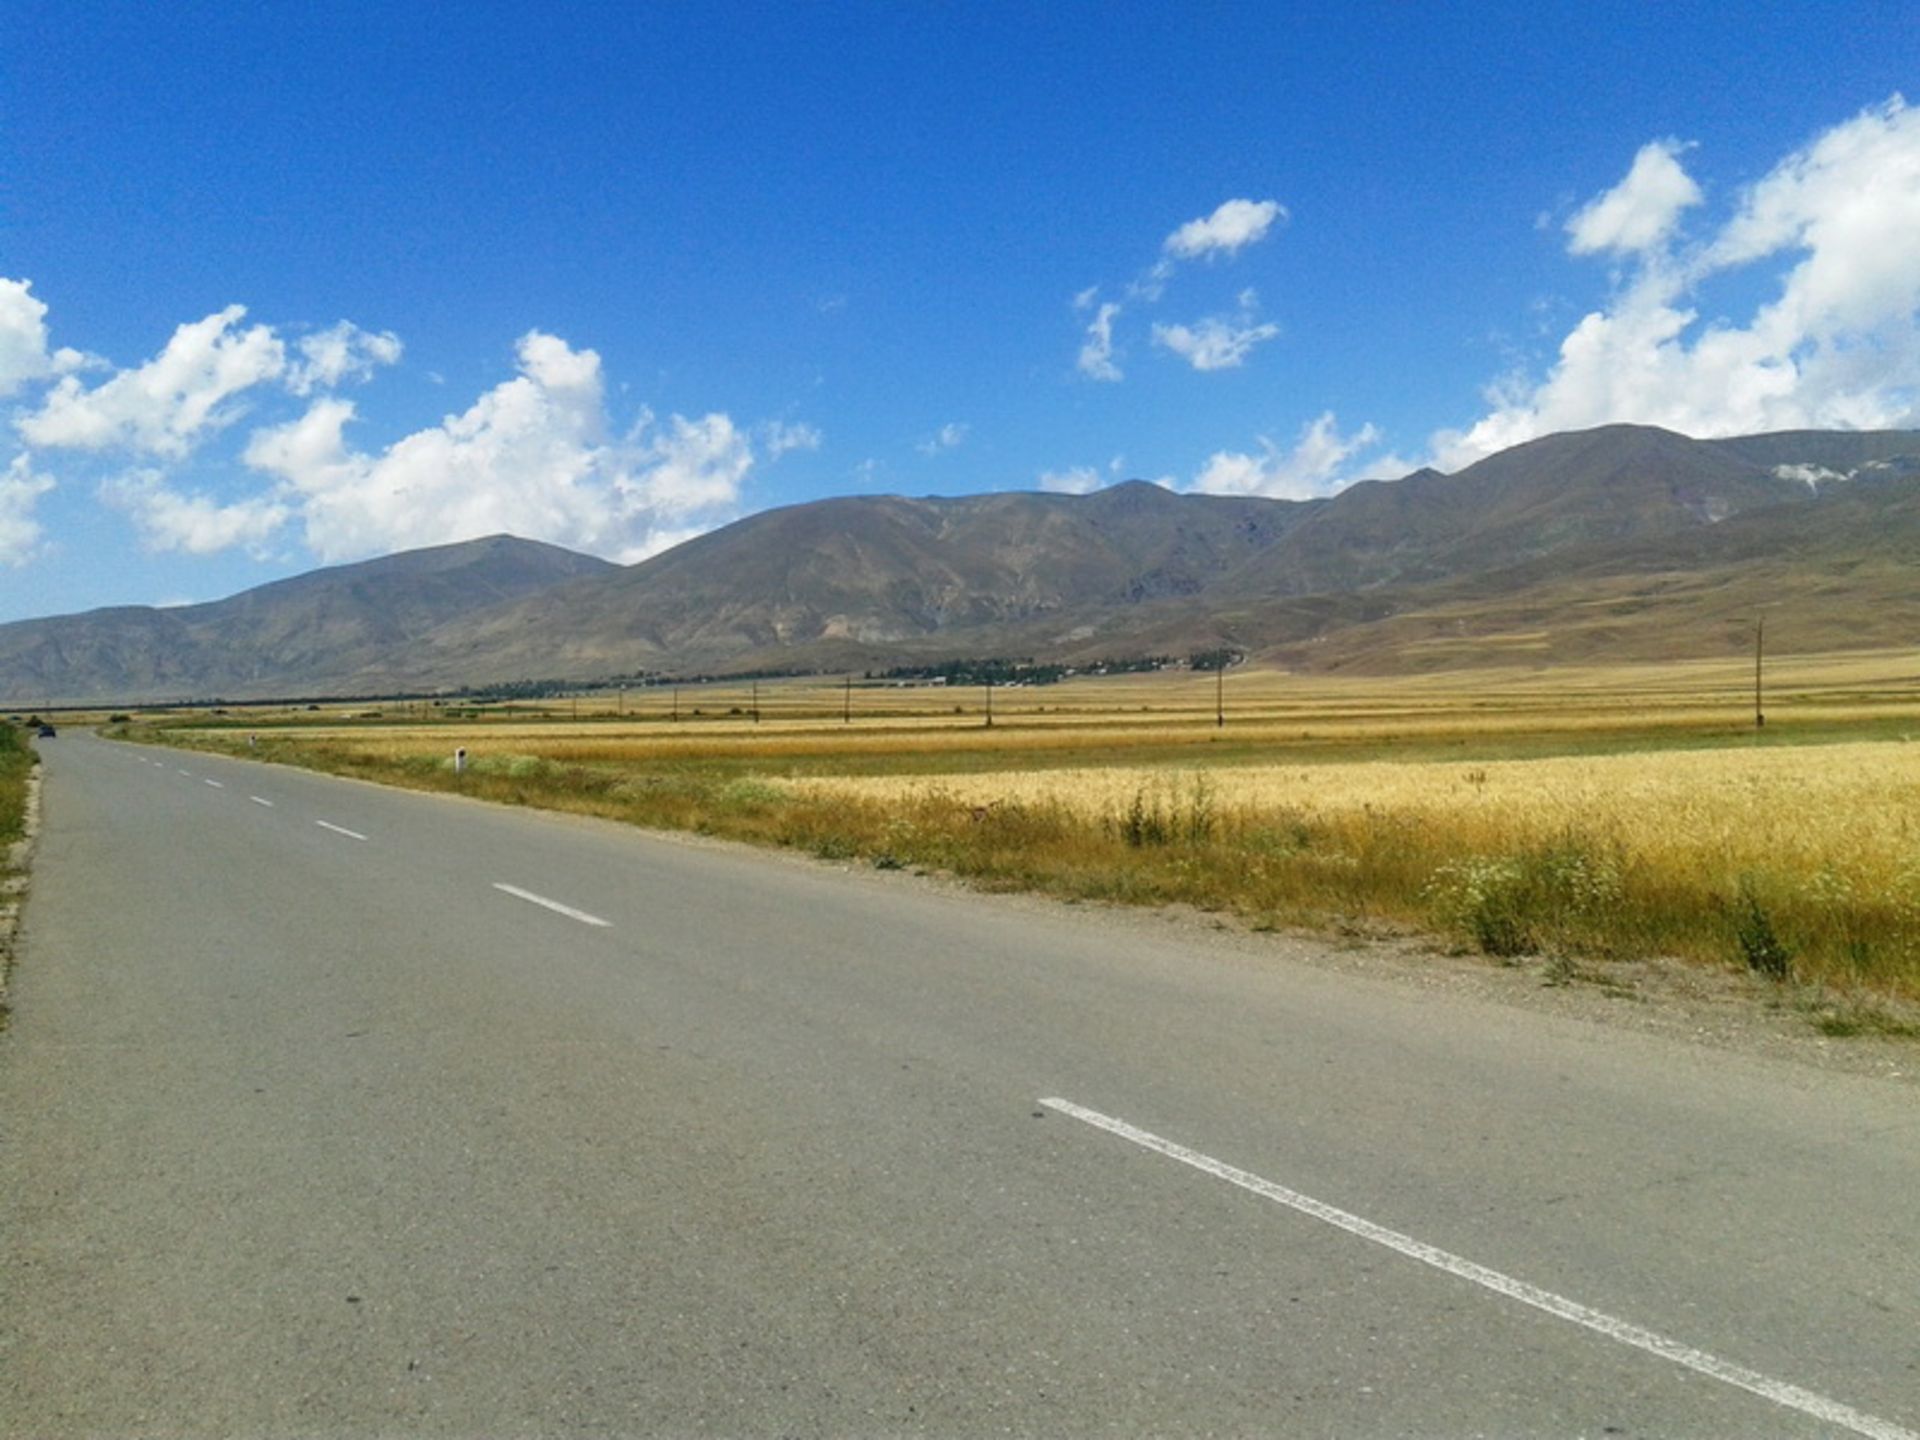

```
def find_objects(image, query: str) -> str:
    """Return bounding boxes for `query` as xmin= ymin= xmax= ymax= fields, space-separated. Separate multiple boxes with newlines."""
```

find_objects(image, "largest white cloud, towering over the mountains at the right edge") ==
xmin=1432 ymin=96 xmax=1920 ymax=468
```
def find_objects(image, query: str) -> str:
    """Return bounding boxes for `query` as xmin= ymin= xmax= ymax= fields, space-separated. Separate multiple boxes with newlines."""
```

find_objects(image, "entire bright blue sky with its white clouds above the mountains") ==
xmin=0 ymin=2 xmax=1920 ymax=620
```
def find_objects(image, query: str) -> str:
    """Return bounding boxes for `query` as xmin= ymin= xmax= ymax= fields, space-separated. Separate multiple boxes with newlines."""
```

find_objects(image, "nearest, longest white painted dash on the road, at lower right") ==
xmin=1041 ymin=1098 xmax=1920 ymax=1440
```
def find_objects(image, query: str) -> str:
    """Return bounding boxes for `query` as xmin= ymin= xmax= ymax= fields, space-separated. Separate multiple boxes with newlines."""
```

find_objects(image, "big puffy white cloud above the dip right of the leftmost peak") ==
xmin=244 ymin=330 xmax=753 ymax=561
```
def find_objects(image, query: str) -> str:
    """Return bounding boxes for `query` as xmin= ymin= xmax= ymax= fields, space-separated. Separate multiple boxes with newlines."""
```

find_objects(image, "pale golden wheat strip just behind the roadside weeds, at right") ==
xmin=781 ymin=741 xmax=1920 ymax=900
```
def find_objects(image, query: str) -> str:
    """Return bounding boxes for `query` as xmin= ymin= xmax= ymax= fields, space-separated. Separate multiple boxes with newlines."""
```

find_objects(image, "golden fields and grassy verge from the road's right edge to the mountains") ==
xmin=123 ymin=655 xmax=1920 ymax=1035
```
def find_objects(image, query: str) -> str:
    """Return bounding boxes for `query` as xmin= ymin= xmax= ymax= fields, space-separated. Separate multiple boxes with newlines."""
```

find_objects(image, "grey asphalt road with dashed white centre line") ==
xmin=0 ymin=732 xmax=1920 ymax=1440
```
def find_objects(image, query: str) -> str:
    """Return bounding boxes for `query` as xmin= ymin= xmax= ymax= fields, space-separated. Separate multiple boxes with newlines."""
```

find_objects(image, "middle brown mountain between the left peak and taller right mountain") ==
xmin=403 ymin=482 xmax=1302 ymax=684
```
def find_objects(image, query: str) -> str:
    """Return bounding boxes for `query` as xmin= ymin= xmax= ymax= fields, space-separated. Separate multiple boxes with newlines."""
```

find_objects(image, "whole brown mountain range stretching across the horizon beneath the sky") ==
xmin=11 ymin=424 xmax=1920 ymax=707
